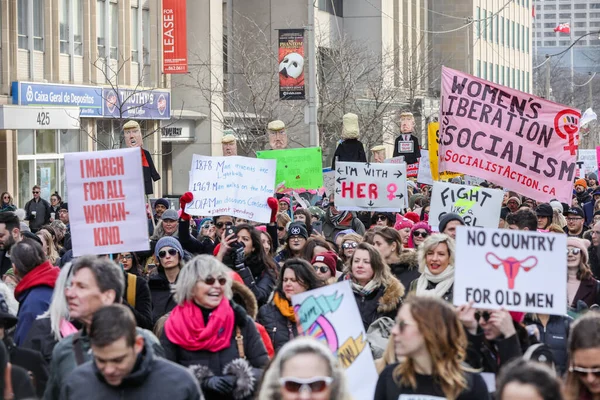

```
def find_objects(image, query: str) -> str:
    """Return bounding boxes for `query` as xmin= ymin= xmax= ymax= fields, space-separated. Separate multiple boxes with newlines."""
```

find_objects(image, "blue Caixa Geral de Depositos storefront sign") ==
xmin=12 ymin=82 xmax=102 ymax=118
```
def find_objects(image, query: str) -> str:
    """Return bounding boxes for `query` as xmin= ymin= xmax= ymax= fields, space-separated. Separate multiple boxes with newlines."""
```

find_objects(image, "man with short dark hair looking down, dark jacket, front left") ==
xmin=61 ymin=304 xmax=204 ymax=400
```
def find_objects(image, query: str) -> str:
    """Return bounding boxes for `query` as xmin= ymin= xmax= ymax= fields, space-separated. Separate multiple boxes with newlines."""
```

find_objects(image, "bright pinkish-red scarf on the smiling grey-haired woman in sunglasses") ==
xmin=165 ymin=298 xmax=235 ymax=353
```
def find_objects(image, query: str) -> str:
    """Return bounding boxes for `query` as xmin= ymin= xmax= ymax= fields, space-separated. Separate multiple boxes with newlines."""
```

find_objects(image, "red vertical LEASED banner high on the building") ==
xmin=162 ymin=0 xmax=188 ymax=74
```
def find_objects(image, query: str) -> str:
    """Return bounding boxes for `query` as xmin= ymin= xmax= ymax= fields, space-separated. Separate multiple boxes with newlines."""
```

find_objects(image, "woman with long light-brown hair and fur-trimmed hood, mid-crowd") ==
xmin=340 ymin=242 xmax=404 ymax=331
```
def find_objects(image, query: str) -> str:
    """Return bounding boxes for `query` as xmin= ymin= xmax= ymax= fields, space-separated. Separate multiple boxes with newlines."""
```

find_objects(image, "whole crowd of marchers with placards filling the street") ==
xmin=0 ymin=81 xmax=600 ymax=400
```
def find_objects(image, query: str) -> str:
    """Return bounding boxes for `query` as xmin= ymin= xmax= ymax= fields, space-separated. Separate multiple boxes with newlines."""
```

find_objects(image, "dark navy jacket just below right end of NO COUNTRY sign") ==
xmin=525 ymin=315 xmax=573 ymax=376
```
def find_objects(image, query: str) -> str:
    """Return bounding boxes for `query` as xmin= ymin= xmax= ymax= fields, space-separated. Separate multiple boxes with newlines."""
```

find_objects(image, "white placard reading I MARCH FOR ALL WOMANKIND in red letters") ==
xmin=65 ymin=147 xmax=150 ymax=257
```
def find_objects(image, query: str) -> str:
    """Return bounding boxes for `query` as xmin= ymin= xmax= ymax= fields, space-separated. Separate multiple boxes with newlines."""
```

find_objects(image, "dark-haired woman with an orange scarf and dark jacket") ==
xmin=256 ymin=258 xmax=323 ymax=352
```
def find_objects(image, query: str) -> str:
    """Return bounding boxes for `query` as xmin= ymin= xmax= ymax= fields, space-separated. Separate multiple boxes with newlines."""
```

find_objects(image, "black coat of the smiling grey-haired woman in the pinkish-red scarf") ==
xmin=160 ymin=302 xmax=269 ymax=400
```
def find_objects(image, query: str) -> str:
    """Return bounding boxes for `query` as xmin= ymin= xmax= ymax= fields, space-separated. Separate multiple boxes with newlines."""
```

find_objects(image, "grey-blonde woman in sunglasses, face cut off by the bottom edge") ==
xmin=258 ymin=337 xmax=352 ymax=400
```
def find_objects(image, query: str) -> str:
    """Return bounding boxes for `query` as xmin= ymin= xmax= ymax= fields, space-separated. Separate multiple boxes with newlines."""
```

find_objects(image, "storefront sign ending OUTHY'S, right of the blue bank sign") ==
xmin=102 ymin=88 xmax=171 ymax=119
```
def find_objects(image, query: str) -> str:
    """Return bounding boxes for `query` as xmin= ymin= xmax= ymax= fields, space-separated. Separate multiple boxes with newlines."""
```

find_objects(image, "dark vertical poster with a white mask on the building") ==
xmin=278 ymin=29 xmax=305 ymax=100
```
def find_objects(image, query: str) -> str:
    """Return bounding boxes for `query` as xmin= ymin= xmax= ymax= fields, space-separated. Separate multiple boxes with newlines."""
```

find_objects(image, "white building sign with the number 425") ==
xmin=0 ymin=105 xmax=80 ymax=130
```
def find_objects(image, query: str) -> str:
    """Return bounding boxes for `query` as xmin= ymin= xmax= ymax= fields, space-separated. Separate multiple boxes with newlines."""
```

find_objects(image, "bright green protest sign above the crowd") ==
xmin=256 ymin=147 xmax=323 ymax=189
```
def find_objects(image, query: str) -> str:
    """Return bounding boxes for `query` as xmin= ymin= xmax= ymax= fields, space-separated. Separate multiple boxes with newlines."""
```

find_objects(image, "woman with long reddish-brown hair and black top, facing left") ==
xmin=374 ymin=296 xmax=489 ymax=400
